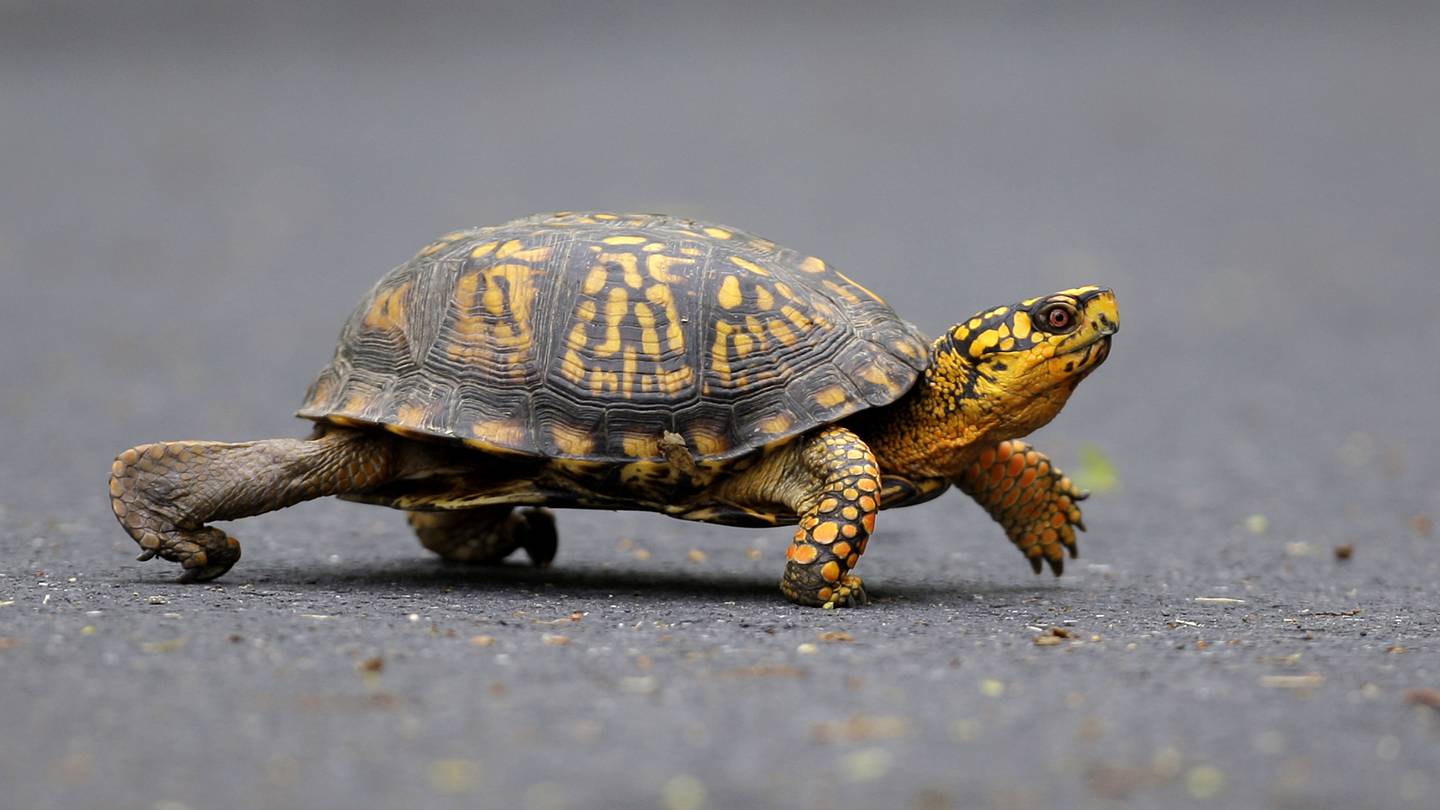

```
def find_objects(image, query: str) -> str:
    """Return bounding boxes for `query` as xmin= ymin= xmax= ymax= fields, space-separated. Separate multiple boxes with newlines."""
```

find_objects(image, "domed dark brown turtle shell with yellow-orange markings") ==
xmin=300 ymin=212 xmax=929 ymax=461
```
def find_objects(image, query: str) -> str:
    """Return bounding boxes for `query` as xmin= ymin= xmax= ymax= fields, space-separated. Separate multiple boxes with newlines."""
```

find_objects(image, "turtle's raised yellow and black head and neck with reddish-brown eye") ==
xmin=881 ymin=287 xmax=1120 ymax=473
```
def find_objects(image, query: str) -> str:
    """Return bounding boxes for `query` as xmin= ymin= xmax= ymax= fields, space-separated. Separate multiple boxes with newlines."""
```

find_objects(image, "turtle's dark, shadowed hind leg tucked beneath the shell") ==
xmin=406 ymin=506 xmax=557 ymax=568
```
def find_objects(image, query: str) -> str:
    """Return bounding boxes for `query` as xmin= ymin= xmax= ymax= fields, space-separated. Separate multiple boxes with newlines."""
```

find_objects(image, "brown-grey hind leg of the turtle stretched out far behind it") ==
xmin=109 ymin=430 xmax=399 ymax=582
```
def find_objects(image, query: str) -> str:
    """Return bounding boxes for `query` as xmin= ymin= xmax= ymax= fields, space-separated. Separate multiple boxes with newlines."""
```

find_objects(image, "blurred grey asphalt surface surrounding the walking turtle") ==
xmin=0 ymin=0 xmax=1440 ymax=810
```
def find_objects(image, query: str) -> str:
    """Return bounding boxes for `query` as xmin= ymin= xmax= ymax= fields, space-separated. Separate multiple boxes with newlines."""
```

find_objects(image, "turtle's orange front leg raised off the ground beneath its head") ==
xmin=955 ymin=441 xmax=1087 ymax=577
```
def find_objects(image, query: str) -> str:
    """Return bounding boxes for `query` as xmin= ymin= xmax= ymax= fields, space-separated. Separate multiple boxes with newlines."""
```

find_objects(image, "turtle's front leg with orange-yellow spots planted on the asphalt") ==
xmin=780 ymin=427 xmax=880 ymax=607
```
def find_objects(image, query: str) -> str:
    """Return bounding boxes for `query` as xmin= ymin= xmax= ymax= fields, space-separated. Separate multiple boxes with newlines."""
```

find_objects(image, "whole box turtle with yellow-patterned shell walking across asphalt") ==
xmin=109 ymin=212 xmax=1120 ymax=607
